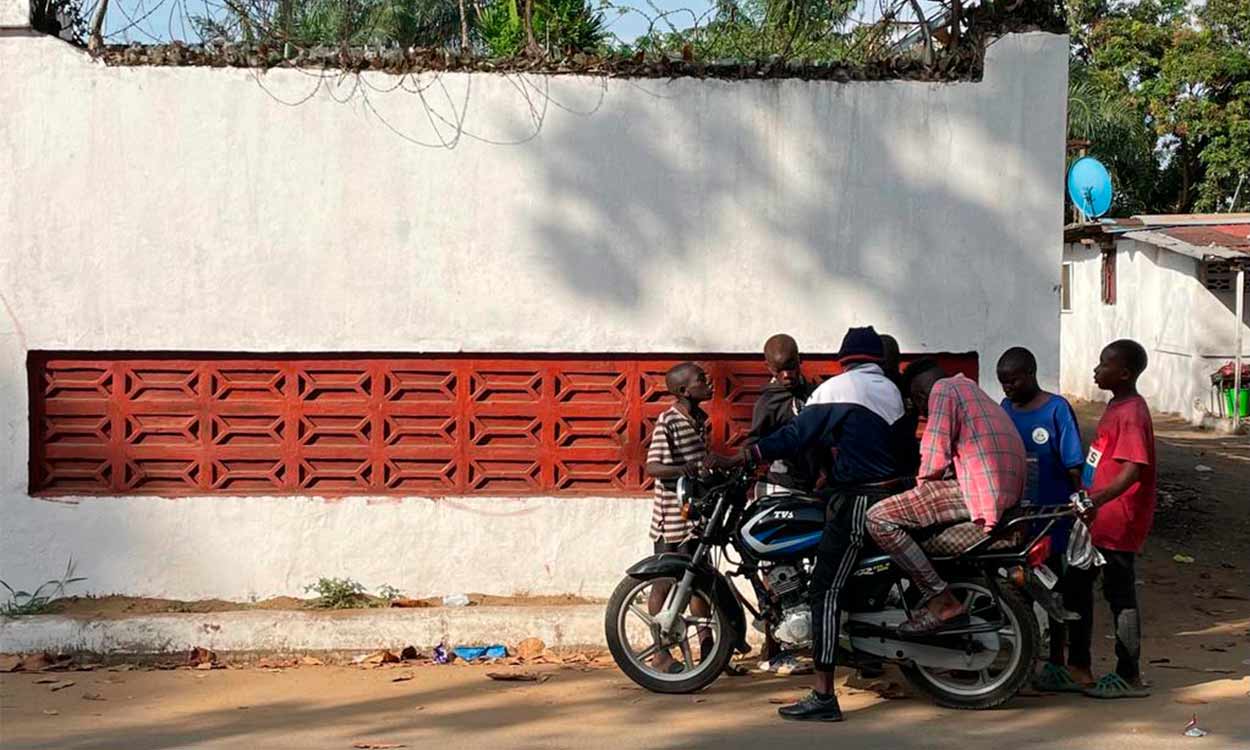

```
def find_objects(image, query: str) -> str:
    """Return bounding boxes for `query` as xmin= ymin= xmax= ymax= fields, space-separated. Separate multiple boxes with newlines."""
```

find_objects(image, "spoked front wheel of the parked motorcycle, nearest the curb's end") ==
xmin=604 ymin=576 xmax=738 ymax=693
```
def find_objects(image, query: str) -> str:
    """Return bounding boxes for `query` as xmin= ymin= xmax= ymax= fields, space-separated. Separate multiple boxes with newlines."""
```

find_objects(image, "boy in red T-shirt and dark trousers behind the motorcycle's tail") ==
xmin=1064 ymin=339 xmax=1156 ymax=698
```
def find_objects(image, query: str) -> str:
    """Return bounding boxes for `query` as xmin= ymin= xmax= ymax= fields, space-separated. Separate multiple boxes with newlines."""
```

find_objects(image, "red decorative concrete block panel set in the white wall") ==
xmin=29 ymin=353 xmax=978 ymax=496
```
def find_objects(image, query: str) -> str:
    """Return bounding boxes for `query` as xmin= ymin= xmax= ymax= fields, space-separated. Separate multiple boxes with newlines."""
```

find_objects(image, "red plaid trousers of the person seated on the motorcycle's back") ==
xmin=868 ymin=480 xmax=973 ymax=599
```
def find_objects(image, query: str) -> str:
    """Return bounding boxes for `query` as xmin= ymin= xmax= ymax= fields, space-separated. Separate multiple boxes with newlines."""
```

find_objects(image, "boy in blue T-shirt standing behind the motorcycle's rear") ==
xmin=998 ymin=346 xmax=1085 ymax=693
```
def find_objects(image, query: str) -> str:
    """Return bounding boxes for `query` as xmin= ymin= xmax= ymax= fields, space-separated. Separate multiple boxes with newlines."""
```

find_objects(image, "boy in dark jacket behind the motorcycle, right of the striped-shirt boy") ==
xmin=746 ymin=334 xmax=816 ymax=498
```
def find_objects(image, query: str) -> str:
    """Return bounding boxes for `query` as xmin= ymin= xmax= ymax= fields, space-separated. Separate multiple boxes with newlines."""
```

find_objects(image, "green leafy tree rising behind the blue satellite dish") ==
xmin=1068 ymin=0 xmax=1250 ymax=214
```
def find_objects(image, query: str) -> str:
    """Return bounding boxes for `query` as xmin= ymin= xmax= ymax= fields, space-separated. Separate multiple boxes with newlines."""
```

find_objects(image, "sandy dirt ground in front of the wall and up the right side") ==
xmin=0 ymin=405 xmax=1250 ymax=750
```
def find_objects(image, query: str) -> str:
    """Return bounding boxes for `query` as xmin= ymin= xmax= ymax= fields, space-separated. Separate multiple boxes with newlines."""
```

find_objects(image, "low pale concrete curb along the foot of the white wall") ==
xmin=0 ymin=604 xmax=606 ymax=654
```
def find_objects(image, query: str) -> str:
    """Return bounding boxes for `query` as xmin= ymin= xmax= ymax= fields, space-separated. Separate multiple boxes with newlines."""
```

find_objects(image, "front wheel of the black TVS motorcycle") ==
xmin=604 ymin=576 xmax=739 ymax=694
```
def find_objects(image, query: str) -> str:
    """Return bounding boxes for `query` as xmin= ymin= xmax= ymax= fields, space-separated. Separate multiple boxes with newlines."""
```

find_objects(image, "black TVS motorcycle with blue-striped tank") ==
xmin=604 ymin=468 xmax=1075 ymax=709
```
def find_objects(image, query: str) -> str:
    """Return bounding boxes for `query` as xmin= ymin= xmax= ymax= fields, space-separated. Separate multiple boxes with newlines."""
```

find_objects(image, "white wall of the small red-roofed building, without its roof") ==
xmin=1060 ymin=240 xmax=1250 ymax=424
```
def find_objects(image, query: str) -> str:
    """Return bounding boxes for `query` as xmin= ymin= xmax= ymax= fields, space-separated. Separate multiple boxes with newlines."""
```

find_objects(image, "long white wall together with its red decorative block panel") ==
xmin=0 ymin=8 xmax=1068 ymax=600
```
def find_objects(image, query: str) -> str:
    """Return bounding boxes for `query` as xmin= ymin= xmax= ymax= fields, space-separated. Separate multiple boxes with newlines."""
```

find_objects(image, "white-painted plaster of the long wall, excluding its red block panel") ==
xmin=0 ymin=34 xmax=1068 ymax=598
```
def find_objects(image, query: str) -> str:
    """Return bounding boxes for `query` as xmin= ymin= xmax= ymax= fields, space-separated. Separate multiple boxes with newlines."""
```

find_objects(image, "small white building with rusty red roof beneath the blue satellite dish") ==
xmin=1060 ymin=214 xmax=1250 ymax=424
